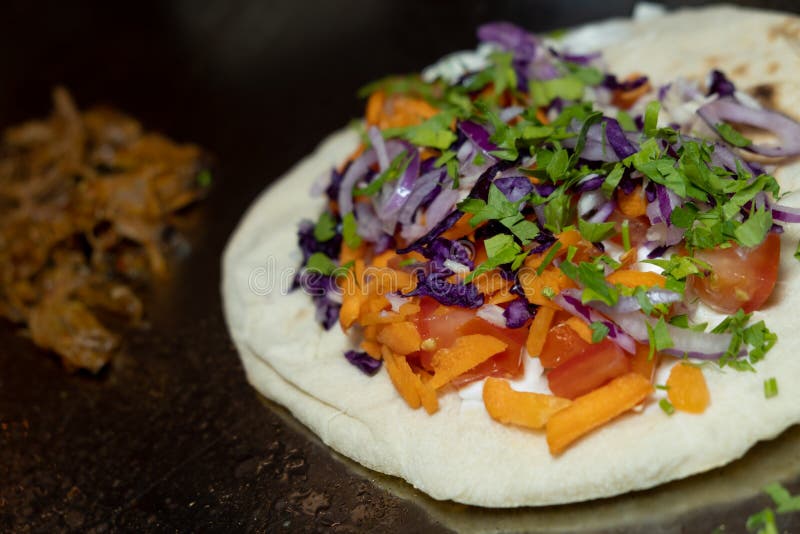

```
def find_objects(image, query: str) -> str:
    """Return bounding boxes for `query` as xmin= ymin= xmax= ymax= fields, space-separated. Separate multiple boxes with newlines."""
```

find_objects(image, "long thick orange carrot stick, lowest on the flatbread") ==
xmin=547 ymin=373 xmax=653 ymax=455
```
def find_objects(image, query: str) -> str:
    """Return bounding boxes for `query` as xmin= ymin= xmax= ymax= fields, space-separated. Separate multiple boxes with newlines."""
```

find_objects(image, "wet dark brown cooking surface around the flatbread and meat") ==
xmin=0 ymin=0 xmax=800 ymax=532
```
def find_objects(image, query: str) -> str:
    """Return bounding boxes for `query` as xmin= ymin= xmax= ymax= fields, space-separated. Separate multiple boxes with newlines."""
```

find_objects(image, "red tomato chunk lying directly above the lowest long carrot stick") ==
xmin=547 ymin=339 xmax=631 ymax=399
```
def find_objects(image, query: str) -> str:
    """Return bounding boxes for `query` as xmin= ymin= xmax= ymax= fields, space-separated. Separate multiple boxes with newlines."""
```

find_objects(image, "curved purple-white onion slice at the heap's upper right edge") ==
xmin=697 ymin=96 xmax=800 ymax=157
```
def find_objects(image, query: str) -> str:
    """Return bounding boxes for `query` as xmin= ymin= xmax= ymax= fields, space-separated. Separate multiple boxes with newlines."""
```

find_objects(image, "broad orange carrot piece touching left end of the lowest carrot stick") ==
xmin=483 ymin=377 xmax=572 ymax=429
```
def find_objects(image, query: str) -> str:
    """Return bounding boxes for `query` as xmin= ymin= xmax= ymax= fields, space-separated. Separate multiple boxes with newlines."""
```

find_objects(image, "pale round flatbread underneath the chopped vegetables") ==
xmin=222 ymin=7 xmax=800 ymax=507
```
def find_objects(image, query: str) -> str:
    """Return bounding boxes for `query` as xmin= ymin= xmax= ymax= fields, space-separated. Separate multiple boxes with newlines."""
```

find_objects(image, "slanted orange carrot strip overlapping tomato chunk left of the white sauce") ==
xmin=428 ymin=334 xmax=508 ymax=389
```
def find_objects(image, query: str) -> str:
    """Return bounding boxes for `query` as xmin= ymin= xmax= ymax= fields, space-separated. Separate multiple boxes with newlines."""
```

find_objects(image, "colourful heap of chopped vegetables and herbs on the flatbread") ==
xmin=297 ymin=23 xmax=800 ymax=454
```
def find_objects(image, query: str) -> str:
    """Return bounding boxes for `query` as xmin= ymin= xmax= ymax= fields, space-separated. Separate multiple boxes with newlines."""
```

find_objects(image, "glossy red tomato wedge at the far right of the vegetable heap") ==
xmin=692 ymin=234 xmax=781 ymax=313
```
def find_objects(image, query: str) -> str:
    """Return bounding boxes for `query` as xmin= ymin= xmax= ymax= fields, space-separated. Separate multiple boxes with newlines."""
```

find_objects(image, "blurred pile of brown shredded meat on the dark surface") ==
xmin=0 ymin=88 xmax=206 ymax=372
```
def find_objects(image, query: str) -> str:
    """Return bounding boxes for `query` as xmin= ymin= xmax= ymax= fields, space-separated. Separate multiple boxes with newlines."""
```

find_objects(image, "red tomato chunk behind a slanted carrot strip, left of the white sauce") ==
xmin=453 ymin=317 xmax=528 ymax=387
